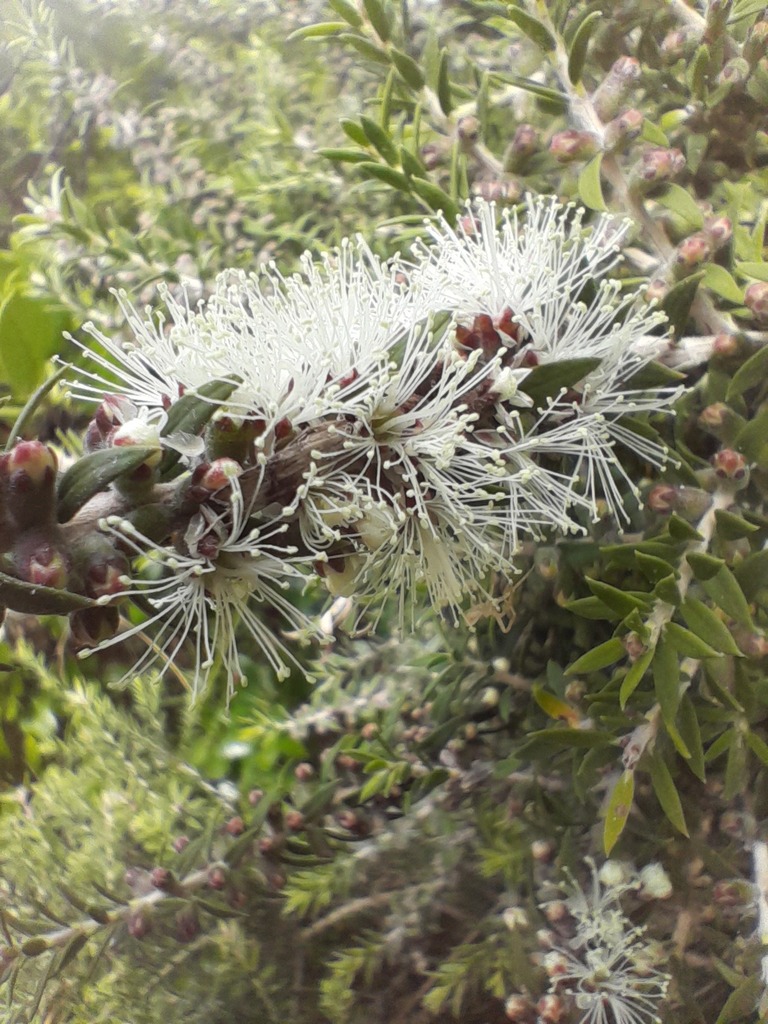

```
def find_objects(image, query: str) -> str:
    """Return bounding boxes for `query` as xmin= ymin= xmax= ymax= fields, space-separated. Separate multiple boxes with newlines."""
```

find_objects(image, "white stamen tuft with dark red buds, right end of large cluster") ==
xmin=412 ymin=199 xmax=677 ymax=516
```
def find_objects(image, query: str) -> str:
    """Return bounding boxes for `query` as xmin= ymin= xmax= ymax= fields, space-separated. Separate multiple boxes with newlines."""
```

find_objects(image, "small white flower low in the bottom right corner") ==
xmin=544 ymin=863 xmax=670 ymax=1024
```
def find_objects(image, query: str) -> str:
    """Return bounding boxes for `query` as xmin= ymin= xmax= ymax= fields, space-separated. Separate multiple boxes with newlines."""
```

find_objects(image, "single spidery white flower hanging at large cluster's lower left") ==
xmin=84 ymin=477 xmax=310 ymax=696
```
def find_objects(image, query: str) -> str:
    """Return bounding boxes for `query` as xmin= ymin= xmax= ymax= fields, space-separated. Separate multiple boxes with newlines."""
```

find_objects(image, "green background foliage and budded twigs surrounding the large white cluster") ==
xmin=0 ymin=0 xmax=768 ymax=1024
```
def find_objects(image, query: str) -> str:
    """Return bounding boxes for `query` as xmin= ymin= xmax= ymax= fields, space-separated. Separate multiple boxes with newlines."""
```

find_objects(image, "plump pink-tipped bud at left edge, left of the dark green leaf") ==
xmin=2 ymin=441 xmax=58 ymax=529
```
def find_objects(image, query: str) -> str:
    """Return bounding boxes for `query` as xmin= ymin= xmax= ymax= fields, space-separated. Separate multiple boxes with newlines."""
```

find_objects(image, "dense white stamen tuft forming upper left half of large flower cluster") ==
xmin=64 ymin=239 xmax=426 ymax=446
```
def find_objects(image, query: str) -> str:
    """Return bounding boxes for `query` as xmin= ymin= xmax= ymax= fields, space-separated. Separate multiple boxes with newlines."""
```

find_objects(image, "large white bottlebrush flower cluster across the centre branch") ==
xmin=64 ymin=199 xmax=674 ymax=685
